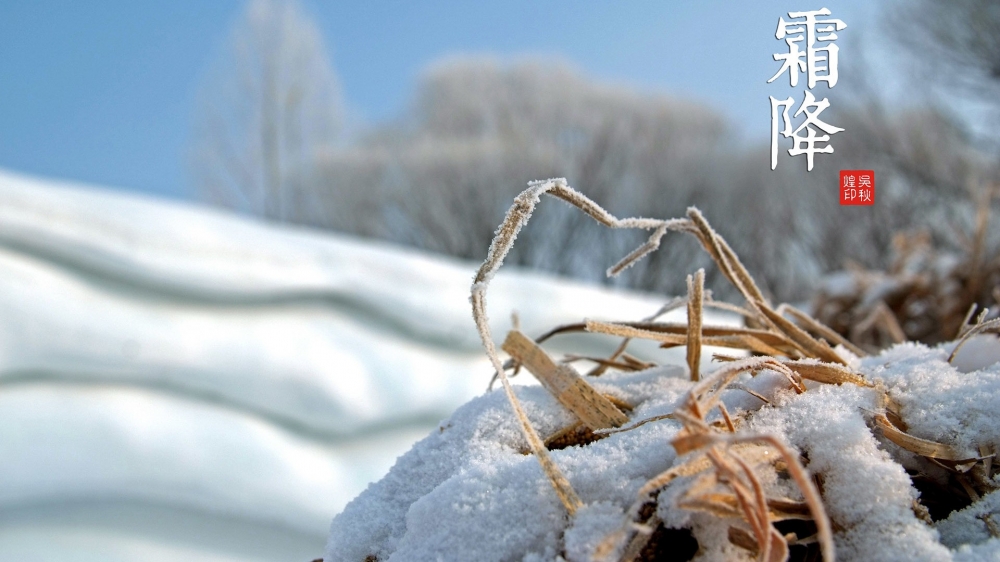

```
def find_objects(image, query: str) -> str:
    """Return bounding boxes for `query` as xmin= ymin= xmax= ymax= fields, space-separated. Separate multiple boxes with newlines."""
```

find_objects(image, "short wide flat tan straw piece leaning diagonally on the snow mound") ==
xmin=502 ymin=330 xmax=628 ymax=429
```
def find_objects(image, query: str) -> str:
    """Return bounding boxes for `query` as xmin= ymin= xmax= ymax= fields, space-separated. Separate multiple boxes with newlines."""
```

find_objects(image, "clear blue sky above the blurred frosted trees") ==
xmin=0 ymin=0 xmax=874 ymax=198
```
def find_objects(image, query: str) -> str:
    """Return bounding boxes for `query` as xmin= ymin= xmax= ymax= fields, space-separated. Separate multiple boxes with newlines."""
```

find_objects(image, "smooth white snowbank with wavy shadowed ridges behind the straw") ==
xmin=0 ymin=171 xmax=700 ymax=562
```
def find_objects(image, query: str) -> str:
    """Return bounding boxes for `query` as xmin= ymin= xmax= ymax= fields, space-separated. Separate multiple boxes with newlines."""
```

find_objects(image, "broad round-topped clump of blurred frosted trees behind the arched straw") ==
xmin=316 ymin=57 xmax=725 ymax=290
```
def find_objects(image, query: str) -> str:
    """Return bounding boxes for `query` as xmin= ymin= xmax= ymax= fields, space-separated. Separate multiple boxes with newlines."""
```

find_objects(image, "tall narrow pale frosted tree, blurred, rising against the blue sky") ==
xmin=191 ymin=0 xmax=340 ymax=221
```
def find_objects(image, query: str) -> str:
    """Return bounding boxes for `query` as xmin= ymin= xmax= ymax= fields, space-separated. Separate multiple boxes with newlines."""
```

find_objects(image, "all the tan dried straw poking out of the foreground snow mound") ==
xmin=471 ymin=179 xmax=1000 ymax=561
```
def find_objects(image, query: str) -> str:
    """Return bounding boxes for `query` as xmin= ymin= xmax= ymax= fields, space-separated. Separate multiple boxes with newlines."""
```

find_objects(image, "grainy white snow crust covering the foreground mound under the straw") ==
xmin=325 ymin=336 xmax=1000 ymax=562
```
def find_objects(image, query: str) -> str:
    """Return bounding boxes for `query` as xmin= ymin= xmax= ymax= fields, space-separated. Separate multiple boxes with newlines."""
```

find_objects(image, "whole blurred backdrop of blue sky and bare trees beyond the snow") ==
xmin=9 ymin=0 xmax=998 ymax=304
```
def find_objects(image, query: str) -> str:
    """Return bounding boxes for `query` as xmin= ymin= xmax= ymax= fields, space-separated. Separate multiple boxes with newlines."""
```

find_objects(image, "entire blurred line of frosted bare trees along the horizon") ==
xmin=193 ymin=0 xmax=995 ymax=299
